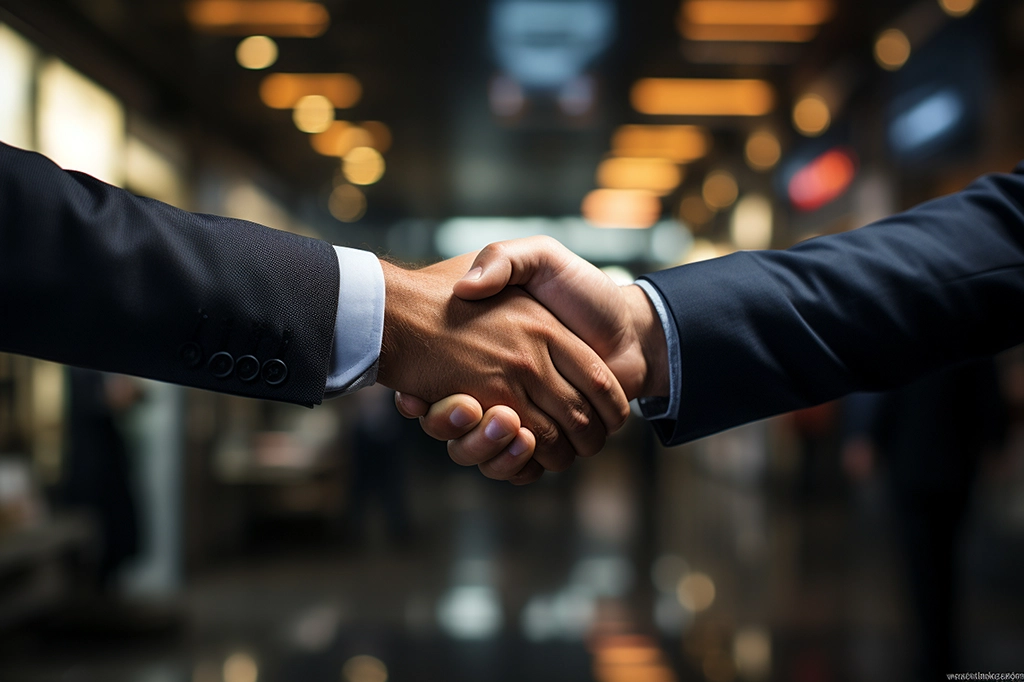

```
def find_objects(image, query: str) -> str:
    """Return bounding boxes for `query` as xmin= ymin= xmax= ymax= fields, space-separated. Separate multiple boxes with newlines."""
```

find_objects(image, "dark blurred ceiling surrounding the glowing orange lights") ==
xmin=0 ymin=0 xmax=934 ymax=223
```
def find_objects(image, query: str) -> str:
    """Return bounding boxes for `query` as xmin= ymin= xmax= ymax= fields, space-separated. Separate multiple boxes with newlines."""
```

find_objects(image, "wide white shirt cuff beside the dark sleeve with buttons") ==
xmin=325 ymin=246 xmax=384 ymax=398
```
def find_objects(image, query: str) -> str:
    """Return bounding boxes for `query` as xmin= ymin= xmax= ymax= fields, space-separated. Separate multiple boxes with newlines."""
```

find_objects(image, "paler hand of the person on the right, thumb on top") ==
xmin=395 ymin=237 xmax=669 ymax=482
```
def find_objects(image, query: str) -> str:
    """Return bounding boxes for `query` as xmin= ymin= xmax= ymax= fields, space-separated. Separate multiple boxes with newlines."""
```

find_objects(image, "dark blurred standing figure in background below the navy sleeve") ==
xmin=843 ymin=358 xmax=1008 ymax=681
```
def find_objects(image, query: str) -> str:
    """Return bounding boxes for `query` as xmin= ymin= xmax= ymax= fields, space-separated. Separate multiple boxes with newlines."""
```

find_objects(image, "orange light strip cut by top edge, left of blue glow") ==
xmin=185 ymin=0 xmax=331 ymax=38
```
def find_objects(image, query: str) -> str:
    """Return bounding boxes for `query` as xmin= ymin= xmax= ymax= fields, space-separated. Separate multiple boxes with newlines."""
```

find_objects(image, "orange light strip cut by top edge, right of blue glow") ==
xmin=683 ymin=0 xmax=835 ymax=26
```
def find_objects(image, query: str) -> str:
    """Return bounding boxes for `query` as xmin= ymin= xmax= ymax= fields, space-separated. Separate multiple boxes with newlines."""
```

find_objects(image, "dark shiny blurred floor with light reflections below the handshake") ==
xmin=0 ymin=417 xmax=1024 ymax=682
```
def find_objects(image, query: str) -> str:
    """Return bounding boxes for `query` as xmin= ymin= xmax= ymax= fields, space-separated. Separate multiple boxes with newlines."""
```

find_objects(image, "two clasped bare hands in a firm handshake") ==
xmin=378 ymin=237 xmax=670 ymax=484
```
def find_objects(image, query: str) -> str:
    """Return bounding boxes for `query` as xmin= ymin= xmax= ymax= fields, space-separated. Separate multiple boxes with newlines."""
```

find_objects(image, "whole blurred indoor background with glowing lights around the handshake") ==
xmin=0 ymin=0 xmax=1024 ymax=682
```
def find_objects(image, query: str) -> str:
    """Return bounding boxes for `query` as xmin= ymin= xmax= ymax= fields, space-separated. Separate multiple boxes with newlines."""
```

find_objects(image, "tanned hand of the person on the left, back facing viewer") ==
xmin=378 ymin=255 xmax=629 ymax=473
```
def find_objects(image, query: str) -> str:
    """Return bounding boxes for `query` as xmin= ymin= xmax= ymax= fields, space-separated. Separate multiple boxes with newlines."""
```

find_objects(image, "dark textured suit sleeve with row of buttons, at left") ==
xmin=0 ymin=143 xmax=339 ymax=406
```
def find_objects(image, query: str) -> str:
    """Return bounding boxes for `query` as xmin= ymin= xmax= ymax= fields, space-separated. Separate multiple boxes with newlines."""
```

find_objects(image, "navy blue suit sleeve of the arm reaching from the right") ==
xmin=645 ymin=164 xmax=1024 ymax=444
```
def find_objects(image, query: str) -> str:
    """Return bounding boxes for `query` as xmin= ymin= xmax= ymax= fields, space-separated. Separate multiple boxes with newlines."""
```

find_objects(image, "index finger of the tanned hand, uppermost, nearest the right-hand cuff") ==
xmin=548 ymin=332 xmax=630 ymax=430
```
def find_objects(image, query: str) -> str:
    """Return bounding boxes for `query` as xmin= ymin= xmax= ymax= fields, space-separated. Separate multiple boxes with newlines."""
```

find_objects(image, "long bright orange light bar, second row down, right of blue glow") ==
xmin=630 ymin=78 xmax=775 ymax=116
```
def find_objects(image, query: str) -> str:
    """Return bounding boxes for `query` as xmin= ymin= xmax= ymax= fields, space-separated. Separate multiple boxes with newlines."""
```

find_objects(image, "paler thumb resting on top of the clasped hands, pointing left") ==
xmin=454 ymin=237 xmax=574 ymax=301
